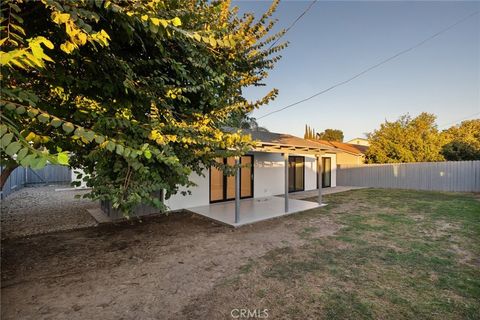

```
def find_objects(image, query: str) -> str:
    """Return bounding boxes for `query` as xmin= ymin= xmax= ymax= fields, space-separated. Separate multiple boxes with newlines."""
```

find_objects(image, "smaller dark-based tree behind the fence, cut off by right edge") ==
xmin=441 ymin=119 xmax=480 ymax=161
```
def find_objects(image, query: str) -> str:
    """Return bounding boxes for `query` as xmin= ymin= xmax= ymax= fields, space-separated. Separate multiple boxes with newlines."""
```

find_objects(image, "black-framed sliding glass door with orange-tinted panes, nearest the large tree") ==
xmin=210 ymin=155 xmax=253 ymax=202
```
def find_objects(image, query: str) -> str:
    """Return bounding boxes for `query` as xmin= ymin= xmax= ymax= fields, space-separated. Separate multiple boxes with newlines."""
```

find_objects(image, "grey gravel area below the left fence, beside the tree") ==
xmin=1 ymin=186 xmax=98 ymax=239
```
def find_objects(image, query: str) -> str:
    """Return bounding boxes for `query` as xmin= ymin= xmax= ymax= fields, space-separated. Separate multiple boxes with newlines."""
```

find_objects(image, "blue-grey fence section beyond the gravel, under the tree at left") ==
xmin=0 ymin=165 xmax=72 ymax=199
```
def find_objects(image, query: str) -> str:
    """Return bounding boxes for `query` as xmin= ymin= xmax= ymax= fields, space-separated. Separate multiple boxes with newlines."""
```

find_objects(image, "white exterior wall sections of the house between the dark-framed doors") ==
xmin=165 ymin=152 xmax=337 ymax=210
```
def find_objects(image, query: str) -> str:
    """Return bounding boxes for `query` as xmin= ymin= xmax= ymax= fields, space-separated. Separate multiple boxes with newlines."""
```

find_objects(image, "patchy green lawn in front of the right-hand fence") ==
xmin=217 ymin=189 xmax=480 ymax=319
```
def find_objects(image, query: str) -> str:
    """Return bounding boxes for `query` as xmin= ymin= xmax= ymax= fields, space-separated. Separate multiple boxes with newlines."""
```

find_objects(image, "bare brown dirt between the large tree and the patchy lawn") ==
xmin=1 ymin=206 xmax=340 ymax=319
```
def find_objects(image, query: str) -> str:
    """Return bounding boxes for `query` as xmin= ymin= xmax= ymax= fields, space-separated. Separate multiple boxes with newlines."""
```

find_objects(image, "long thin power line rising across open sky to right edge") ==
xmin=257 ymin=11 xmax=479 ymax=120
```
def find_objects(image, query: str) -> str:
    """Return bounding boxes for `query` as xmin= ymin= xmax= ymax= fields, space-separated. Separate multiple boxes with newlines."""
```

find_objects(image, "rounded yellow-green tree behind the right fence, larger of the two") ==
xmin=365 ymin=113 xmax=446 ymax=163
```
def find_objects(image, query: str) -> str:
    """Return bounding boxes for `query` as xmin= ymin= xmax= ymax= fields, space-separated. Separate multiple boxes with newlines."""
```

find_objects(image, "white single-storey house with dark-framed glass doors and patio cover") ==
xmin=159 ymin=131 xmax=337 ymax=225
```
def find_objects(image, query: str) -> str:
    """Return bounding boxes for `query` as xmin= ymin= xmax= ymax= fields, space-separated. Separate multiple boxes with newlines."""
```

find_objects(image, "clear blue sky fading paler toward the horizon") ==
xmin=233 ymin=1 xmax=480 ymax=141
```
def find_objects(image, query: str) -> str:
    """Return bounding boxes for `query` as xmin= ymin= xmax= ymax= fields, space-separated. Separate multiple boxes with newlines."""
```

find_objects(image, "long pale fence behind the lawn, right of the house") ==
xmin=337 ymin=161 xmax=480 ymax=192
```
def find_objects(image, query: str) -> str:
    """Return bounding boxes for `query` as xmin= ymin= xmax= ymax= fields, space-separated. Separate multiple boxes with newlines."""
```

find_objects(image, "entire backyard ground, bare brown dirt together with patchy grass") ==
xmin=1 ymin=189 xmax=480 ymax=319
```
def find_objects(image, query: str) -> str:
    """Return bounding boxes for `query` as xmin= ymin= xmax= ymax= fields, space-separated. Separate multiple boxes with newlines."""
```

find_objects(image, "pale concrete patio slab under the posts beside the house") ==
xmin=187 ymin=197 xmax=325 ymax=227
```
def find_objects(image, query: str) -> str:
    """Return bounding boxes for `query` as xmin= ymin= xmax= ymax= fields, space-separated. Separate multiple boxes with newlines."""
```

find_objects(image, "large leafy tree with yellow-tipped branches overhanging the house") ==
xmin=0 ymin=0 xmax=286 ymax=212
